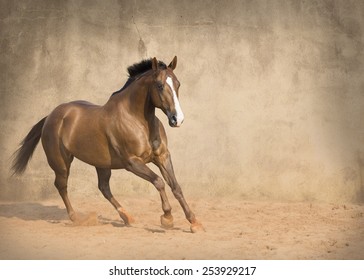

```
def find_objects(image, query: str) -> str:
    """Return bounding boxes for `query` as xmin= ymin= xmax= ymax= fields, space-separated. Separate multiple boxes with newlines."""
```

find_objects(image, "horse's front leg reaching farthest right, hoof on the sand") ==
xmin=155 ymin=151 xmax=204 ymax=233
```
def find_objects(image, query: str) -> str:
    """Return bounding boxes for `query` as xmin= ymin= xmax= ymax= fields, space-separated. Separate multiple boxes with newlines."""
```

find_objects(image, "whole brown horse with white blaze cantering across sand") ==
xmin=12 ymin=57 xmax=203 ymax=232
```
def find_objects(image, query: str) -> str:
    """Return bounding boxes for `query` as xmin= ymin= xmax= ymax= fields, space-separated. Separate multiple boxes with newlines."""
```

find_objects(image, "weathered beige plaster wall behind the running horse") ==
xmin=0 ymin=0 xmax=364 ymax=203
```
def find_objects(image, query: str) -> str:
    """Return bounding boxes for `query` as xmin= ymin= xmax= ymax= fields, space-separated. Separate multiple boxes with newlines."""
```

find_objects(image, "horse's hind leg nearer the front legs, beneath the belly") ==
xmin=96 ymin=167 xmax=134 ymax=225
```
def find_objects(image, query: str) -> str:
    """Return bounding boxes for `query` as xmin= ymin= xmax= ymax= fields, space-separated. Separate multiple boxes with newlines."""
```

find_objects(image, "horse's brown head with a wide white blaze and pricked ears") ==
xmin=151 ymin=56 xmax=184 ymax=127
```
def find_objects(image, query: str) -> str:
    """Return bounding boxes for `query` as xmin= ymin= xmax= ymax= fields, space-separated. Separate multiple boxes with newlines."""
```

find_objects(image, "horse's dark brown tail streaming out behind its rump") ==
xmin=11 ymin=117 xmax=47 ymax=174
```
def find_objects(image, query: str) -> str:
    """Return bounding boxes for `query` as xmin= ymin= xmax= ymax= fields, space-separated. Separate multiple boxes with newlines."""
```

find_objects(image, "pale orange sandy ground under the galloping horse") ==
xmin=0 ymin=194 xmax=364 ymax=259
